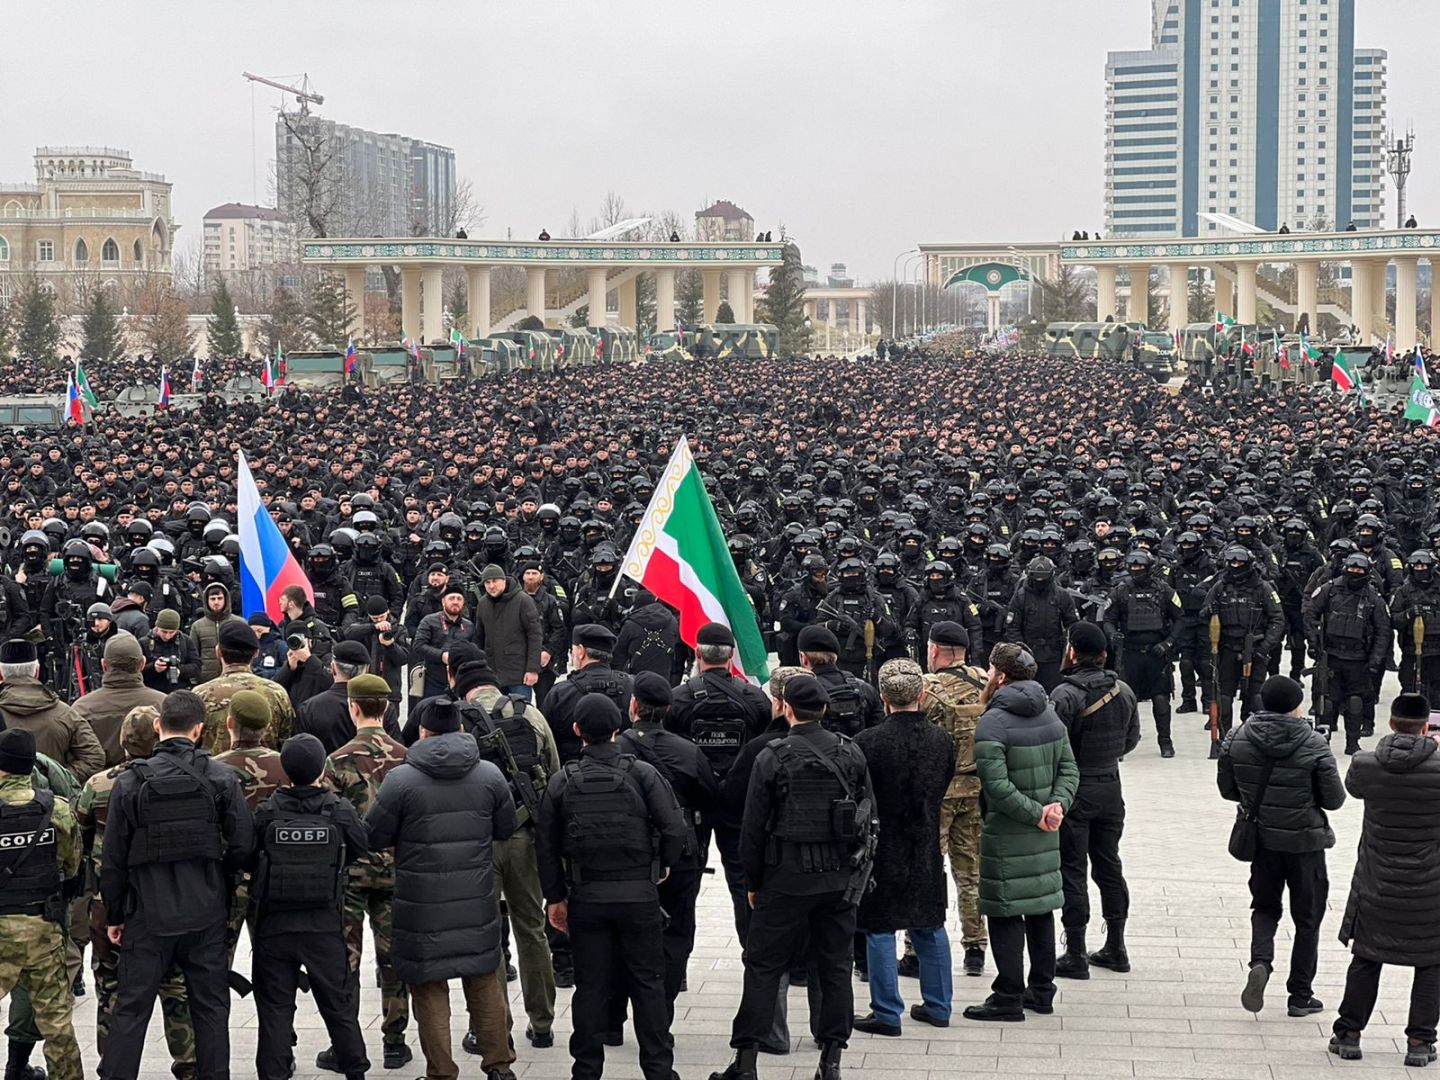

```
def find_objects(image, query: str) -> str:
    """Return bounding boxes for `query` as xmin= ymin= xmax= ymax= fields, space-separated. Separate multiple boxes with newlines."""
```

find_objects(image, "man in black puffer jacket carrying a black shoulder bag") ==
xmin=1217 ymin=675 xmax=1345 ymax=1017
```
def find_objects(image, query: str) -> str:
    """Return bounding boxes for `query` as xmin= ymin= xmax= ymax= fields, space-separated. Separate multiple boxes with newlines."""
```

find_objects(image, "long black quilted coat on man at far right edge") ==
xmin=1341 ymin=734 xmax=1440 ymax=968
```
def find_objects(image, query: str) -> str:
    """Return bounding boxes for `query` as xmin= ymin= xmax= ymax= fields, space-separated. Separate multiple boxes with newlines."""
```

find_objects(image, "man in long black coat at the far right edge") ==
xmin=1331 ymin=694 xmax=1440 ymax=1067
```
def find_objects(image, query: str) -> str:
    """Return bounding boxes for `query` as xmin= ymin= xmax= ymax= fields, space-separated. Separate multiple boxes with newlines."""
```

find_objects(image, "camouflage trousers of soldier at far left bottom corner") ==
xmin=0 ymin=914 xmax=85 ymax=1080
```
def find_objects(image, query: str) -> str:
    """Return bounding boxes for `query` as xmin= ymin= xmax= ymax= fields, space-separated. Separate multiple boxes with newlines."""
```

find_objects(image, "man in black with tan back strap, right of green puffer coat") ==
xmin=1051 ymin=622 xmax=1134 ymax=979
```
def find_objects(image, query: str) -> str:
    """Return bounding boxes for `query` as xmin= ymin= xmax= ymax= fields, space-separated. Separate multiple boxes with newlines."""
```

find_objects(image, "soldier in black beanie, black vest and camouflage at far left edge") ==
xmin=0 ymin=730 xmax=85 ymax=1080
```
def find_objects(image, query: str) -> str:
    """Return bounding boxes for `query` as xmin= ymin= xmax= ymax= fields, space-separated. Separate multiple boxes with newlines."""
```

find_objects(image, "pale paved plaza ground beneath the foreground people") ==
xmin=76 ymin=685 xmax=1440 ymax=1080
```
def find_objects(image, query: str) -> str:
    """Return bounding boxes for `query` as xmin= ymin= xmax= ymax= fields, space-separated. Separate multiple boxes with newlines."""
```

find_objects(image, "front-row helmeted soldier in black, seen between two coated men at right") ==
xmin=1305 ymin=552 xmax=1390 ymax=753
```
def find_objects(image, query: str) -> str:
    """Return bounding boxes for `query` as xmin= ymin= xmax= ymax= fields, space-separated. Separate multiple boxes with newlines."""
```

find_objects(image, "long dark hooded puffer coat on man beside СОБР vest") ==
xmin=366 ymin=732 xmax=517 ymax=985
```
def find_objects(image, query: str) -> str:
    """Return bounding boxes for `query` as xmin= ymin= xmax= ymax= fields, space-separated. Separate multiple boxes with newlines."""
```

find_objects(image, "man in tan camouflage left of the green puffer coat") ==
xmin=922 ymin=622 xmax=986 ymax=975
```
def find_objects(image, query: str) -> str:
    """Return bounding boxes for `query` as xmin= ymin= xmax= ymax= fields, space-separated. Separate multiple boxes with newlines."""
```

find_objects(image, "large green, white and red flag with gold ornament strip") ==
xmin=621 ymin=436 xmax=770 ymax=683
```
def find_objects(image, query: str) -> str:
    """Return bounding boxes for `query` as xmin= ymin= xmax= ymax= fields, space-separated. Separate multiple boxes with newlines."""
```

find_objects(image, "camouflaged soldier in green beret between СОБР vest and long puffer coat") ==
xmin=324 ymin=675 xmax=415 ymax=1070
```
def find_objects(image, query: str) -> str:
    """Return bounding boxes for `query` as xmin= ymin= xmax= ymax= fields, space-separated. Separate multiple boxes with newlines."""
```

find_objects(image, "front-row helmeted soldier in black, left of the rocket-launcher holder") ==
xmin=1100 ymin=547 xmax=1181 ymax=754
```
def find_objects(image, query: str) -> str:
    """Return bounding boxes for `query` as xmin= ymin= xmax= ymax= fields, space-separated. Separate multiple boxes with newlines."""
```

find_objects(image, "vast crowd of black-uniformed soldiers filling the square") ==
xmin=0 ymin=338 xmax=1440 ymax=1080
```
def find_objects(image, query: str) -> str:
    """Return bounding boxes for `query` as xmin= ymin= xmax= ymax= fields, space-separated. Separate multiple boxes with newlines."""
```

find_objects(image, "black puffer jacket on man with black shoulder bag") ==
xmin=1217 ymin=713 xmax=1345 ymax=852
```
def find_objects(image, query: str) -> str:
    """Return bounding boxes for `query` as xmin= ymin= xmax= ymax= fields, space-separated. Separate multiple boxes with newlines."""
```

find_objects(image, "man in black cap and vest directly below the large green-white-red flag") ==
xmin=665 ymin=622 xmax=770 ymax=927
